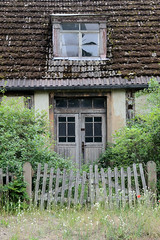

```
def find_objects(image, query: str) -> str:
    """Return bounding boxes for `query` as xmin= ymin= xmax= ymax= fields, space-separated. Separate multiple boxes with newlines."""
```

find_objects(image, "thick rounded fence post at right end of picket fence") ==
xmin=147 ymin=161 xmax=157 ymax=199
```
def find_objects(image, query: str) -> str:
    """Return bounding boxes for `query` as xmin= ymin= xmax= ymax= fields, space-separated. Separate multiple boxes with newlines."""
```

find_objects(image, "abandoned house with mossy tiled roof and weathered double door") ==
xmin=0 ymin=0 xmax=160 ymax=166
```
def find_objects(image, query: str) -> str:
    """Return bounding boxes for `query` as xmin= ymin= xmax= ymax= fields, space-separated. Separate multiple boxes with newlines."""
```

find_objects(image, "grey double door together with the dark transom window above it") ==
xmin=54 ymin=98 xmax=106 ymax=167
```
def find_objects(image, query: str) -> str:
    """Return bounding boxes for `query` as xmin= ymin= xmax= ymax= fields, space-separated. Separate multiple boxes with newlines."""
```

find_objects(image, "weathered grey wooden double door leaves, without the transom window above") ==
xmin=55 ymin=111 xmax=106 ymax=167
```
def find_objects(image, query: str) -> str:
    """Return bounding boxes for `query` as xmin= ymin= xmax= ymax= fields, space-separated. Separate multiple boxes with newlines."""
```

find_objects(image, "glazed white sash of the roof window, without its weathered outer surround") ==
xmin=60 ymin=23 xmax=99 ymax=57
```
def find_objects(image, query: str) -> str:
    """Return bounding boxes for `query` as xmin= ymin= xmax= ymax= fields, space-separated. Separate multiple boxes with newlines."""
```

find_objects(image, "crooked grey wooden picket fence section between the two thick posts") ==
xmin=34 ymin=162 xmax=156 ymax=209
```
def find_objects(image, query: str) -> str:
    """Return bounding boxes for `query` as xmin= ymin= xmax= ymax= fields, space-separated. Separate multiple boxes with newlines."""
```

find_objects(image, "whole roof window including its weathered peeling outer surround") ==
xmin=51 ymin=14 xmax=107 ymax=60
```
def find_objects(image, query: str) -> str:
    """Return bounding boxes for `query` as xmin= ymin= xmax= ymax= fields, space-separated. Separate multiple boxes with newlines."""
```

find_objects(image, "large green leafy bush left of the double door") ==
xmin=0 ymin=98 xmax=71 ymax=173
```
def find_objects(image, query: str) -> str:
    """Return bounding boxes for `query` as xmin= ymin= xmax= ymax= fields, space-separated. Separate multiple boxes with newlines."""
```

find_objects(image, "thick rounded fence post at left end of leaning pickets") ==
xmin=23 ymin=162 xmax=33 ymax=200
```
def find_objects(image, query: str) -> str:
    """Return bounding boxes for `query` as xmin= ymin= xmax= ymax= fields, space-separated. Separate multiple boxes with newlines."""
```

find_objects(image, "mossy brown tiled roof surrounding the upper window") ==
xmin=0 ymin=0 xmax=160 ymax=87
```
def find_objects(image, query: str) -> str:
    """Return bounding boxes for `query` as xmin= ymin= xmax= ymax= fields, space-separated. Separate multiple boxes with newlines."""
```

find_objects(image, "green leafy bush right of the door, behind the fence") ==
xmin=99 ymin=79 xmax=160 ymax=191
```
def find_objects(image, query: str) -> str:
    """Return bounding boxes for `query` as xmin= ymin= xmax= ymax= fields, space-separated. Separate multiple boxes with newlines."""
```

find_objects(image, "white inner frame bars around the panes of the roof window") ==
xmin=60 ymin=22 xmax=100 ymax=59
